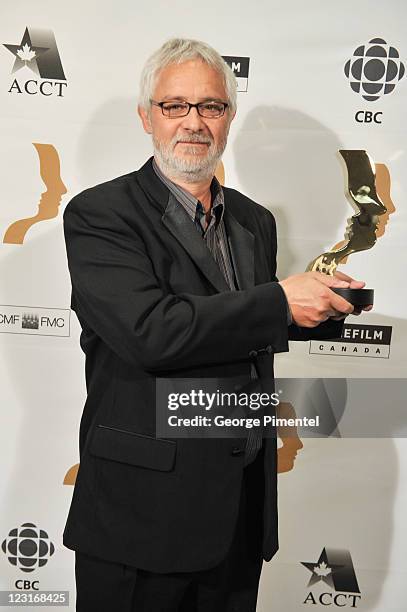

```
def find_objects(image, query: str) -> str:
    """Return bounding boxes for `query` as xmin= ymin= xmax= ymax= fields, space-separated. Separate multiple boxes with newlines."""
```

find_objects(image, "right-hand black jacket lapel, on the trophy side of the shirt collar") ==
xmin=224 ymin=208 xmax=254 ymax=289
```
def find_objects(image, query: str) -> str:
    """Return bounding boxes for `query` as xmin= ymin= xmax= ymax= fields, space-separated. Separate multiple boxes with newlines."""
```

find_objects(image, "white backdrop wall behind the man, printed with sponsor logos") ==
xmin=0 ymin=0 xmax=407 ymax=612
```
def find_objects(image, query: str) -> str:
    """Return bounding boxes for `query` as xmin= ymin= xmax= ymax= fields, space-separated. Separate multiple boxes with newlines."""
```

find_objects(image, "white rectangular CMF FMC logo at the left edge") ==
xmin=0 ymin=305 xmax=71 ymax=338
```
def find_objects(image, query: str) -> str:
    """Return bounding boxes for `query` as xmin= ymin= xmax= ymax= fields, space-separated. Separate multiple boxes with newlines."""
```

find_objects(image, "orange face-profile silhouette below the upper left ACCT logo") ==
xmin=3 ymin=142 xmax=67 ymax=244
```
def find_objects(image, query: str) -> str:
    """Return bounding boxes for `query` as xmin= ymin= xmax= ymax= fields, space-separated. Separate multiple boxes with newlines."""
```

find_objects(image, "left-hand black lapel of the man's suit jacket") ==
xmin=162 ymin=193 xmax=233 ymax=291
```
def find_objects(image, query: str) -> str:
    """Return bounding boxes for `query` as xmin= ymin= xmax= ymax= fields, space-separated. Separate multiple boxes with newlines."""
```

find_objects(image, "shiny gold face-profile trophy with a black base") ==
xmin=307 ymin=149 xmax=387 ymax=306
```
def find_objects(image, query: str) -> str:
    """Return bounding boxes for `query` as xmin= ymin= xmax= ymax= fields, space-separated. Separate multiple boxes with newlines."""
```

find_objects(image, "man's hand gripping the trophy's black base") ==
xmin=280 ymin=272 xmax=364 ymax=327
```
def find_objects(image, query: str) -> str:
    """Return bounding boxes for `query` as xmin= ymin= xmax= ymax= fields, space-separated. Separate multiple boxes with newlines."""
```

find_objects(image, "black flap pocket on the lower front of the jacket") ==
xmin=89 ymin=424 xmax=177 ymax=472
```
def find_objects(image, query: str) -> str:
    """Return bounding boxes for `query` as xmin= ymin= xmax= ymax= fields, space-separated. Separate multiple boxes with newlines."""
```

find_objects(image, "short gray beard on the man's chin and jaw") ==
xmin=153 ymin=136 xmax=226 ymax=183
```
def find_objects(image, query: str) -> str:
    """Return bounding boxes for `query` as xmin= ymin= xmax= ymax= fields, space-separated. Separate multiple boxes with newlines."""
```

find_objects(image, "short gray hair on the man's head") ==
xmin=139 ymin=38 xmax=237 ymax=113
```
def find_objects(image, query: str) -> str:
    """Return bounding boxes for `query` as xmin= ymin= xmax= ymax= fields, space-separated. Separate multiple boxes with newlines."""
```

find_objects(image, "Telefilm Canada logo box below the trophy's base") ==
xmin=309 ymin=323 xmax=393 ymax=359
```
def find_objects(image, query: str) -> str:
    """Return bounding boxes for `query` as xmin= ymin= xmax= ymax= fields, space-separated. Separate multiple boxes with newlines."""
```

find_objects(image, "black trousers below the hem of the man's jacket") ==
xmin=75 ymin=450 xmax=264 ymax=612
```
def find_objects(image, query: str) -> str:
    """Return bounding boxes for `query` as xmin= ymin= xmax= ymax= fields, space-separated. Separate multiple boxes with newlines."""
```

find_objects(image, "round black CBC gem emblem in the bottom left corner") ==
xmin=1 ymin=523 xmax=55 ymax=572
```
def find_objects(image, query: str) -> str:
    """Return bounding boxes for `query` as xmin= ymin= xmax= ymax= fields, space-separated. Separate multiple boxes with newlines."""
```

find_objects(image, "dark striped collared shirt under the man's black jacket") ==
xmin=153 ymin=159 xmax=262 ymax=465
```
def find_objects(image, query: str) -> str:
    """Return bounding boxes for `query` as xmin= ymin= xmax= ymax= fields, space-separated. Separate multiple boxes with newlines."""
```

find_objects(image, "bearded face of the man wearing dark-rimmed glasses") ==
xmin=139 ymin=59 xmax=234 ymax=182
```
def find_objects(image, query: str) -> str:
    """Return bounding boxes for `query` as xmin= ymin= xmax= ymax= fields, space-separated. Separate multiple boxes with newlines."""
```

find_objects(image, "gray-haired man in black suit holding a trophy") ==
xmin=64 ymin=39 xmax=370 ymax=612
